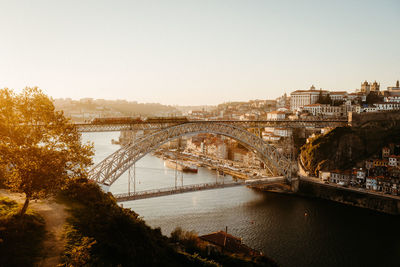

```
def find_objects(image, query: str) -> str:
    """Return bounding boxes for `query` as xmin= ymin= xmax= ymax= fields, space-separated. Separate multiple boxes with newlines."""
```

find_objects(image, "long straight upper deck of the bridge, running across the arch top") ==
xmin=75 ymin=119 xmax=348 ymax=132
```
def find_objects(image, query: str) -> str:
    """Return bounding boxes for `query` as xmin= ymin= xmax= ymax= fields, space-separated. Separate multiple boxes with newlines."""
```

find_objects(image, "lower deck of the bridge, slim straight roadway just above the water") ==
xmin=114 ymin=176 xmax=285 ymax=202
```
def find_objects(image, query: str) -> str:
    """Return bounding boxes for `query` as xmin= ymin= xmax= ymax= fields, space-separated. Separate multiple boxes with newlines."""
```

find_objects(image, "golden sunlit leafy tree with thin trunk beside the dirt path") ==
xmin=0 ymin=88 xmax=93 ymax=216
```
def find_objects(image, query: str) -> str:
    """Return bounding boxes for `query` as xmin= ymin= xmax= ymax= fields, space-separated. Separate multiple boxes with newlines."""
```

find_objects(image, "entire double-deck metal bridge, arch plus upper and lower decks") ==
xmin=84 ymin=118 xmax=340 ymax=200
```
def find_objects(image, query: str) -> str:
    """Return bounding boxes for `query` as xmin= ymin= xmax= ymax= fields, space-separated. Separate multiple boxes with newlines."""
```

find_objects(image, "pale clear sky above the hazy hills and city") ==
xmin=0 ymin=0 xmax=400 ymax=105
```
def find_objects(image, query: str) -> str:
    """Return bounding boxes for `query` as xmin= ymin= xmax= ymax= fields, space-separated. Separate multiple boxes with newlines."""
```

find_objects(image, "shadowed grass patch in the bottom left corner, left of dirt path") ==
xmin=0 ymin=197 xmax=45 ymax=266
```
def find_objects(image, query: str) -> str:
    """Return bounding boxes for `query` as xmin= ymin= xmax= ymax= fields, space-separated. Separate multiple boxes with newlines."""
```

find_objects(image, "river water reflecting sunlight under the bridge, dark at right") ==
xmin=82 ymin=133 xmax=400 ymax=267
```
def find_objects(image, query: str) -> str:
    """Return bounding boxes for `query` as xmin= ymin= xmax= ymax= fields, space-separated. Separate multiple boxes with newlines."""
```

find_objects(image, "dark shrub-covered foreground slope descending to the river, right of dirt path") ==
xmin=59 ymin=179 xmax=277 ymax=267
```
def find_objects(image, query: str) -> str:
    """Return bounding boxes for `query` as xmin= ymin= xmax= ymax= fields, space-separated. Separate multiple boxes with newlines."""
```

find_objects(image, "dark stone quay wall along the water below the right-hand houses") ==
xmin=297 ymin=179 xmax=400 ymax=215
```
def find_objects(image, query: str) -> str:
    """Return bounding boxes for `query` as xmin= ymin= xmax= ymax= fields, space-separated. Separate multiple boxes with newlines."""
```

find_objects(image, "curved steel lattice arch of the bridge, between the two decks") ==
xmin=89 ymin=122 xmax=296 ymax=186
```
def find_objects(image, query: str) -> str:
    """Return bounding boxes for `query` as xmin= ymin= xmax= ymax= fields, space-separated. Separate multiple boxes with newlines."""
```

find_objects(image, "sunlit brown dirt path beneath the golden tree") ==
xmin=0 ymin=189 xmax=68 ymax=267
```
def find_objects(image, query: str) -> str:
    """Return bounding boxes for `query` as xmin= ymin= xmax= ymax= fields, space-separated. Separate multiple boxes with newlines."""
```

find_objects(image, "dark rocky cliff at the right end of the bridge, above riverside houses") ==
xmin=300 ymin=120 xmax=400 ymax=175
